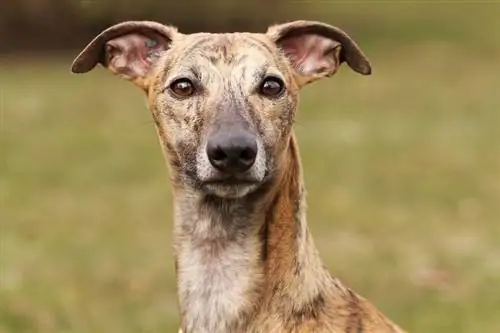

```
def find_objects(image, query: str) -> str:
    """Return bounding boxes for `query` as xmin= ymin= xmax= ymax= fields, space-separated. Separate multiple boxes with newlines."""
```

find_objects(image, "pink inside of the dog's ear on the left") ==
xmin=106 ymin=34 xmax=165 ymax=78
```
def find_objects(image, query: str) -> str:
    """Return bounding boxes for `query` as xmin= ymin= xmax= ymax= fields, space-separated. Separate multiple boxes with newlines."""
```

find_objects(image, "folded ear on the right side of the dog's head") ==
xmin=266 ymin=21 xmax=371 ymax=86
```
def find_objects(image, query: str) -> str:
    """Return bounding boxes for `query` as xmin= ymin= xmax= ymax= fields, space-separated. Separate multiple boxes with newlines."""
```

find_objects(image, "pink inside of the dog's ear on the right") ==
xmin=280 ymin=34 xmax=340 ymax=75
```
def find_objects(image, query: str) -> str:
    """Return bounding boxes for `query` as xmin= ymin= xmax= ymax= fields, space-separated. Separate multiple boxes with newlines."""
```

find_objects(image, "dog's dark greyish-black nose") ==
xmin=207 ymin=132 xmax=257 ymax=173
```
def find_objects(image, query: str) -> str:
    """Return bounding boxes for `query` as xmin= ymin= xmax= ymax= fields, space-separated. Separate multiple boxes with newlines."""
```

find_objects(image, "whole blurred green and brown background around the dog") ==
xmin=0 ymin=0 xmax=500 ymax=333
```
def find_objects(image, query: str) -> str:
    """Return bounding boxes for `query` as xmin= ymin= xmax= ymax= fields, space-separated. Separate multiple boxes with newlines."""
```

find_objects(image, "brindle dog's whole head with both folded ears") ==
xmin=72 ymin=21 xmax=371 ymax=198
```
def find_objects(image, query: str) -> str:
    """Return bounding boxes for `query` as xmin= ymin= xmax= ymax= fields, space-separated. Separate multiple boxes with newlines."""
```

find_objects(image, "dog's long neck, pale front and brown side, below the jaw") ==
xmin=169 ymin=136 xmax=332 ymax=333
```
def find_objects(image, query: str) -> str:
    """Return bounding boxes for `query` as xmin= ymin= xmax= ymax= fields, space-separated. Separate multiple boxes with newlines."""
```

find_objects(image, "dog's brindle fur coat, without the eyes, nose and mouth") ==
xmin=72 ymin=21 xmax=402 ymax=333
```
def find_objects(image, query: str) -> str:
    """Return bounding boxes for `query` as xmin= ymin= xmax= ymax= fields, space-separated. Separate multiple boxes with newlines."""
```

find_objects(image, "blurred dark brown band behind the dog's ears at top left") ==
xmin=0 ymin=0 xmax=304 ymax=51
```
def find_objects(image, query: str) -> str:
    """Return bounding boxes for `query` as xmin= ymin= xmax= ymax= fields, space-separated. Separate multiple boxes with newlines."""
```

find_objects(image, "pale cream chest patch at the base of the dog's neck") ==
xmin=178 ymin=236 xmax=258 ymax=333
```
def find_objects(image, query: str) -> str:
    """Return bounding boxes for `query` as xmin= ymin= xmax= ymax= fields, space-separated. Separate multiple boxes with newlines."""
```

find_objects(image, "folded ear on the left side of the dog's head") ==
xmin=71 ymin=21 xmax=179 ymax=90
